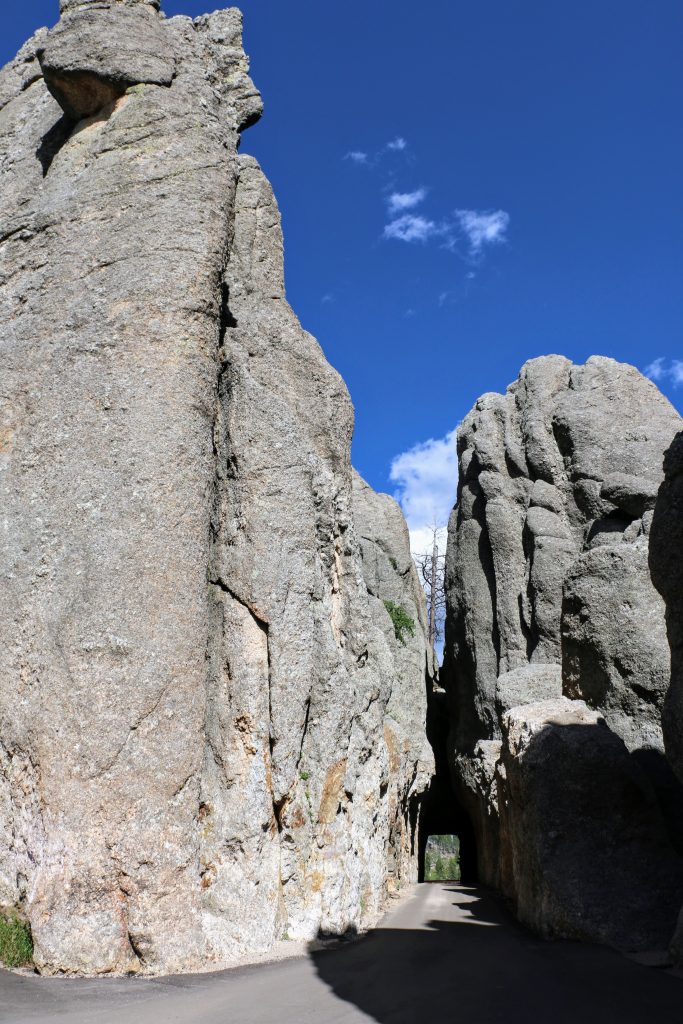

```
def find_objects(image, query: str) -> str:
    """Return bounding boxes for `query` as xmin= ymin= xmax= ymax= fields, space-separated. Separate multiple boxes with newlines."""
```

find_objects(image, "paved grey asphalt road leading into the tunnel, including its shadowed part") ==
xmin=0 ymin=884 xmax=683 ymax=1024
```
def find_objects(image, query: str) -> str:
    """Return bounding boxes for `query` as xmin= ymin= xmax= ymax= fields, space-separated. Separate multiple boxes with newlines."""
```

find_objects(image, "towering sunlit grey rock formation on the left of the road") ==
xmin=0 ymin=2 xmax=429 ymax=973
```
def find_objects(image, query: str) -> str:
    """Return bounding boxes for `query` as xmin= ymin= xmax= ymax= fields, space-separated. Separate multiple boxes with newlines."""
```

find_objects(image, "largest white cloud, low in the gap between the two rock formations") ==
xmin=389 ymin=430 xmax=458 ymax=552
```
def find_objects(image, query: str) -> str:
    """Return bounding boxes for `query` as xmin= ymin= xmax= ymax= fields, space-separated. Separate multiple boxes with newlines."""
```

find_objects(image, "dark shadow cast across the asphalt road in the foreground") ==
xmin=310 ymin=886 xmax=683 ymax=1024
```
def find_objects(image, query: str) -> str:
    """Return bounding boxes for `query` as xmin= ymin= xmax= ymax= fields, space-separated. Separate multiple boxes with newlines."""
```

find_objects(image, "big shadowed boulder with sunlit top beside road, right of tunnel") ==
xmin=499 ymin=697 xmax=683 ymax=950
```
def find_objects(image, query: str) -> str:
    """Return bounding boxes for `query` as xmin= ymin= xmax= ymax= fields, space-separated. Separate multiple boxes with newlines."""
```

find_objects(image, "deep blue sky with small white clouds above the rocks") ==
xmin=5 ymin=0 xmax=683 ymax=552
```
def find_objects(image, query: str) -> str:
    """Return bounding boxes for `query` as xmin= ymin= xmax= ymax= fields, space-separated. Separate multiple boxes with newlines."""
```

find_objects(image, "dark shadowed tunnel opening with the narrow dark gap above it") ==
xmin=418 ymin=688 xmax=477 ymax=882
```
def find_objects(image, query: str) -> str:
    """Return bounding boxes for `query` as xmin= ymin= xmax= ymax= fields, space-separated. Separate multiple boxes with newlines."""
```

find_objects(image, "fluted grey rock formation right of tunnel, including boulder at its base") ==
xmin=444 ymin=356 xmax=683 ymax=948
